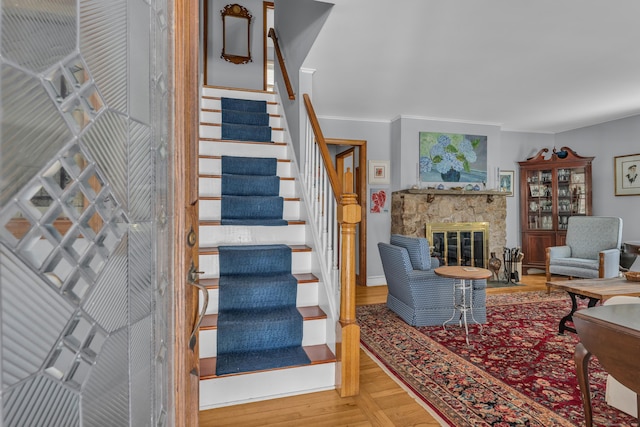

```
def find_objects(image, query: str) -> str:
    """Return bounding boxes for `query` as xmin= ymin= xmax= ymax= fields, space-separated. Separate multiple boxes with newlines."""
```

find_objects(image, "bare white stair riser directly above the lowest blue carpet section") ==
xmin=200 ymin=224 xmax=306 ymax=247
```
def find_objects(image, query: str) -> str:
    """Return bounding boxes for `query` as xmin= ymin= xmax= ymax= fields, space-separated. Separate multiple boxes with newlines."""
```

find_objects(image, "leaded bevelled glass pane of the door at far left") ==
xmin=0 ymin=0 xmax=172 ymax=427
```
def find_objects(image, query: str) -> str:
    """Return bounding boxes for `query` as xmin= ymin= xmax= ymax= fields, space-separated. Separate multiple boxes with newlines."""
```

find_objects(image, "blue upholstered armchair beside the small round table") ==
xmin=378 ymin=234 xmax=487 ymax=326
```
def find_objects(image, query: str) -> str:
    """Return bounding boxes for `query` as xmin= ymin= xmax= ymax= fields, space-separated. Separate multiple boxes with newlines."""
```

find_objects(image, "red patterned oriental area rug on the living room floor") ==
xmin=357 ymin=292 xmax=637 ymax=427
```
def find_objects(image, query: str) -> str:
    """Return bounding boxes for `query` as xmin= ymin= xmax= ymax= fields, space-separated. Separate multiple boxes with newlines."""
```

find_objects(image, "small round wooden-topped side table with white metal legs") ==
xmin=434 ymin=265 xmax=491 ymax=344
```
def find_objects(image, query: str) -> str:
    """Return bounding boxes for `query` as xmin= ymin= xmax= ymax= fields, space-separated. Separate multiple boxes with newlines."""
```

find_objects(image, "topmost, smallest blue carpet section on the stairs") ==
xmin=221 ymin=98 xmax=271 ymax=142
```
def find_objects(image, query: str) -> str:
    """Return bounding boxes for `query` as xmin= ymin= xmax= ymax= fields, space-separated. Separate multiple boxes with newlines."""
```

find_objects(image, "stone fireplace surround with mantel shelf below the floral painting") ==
xmin=391 ymin=189 xmax=507 ymax=268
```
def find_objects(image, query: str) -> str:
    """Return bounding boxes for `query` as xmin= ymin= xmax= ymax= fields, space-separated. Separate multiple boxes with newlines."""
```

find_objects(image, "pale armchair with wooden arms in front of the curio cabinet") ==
xmin=546 ymin=216 xmax=622 ymax=290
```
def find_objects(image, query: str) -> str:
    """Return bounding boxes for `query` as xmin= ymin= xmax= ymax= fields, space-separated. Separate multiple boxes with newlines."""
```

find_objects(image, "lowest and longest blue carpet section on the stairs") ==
xmin=216 ymin=245 xmax=310 ymax=375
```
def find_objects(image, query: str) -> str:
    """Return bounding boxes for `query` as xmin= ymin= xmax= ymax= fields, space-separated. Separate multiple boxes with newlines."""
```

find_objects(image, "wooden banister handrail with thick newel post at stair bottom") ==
xmin=302 ymin=93 xmax=362 ymax=397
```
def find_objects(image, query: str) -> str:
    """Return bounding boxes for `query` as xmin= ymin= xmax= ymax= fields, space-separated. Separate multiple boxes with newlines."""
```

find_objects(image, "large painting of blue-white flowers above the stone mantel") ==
xmin=418 ymin=132 xmax=487 ymax=182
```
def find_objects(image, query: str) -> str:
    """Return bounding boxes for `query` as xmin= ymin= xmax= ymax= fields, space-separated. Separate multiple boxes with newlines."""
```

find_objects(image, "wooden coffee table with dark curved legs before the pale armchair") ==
xmin=547 ymin=277 xmax=640 ymax=334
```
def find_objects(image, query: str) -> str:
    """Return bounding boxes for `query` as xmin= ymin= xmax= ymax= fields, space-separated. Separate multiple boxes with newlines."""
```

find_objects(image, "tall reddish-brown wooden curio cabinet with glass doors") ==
xmin=518 ymin=147 xmax=594 ymax=274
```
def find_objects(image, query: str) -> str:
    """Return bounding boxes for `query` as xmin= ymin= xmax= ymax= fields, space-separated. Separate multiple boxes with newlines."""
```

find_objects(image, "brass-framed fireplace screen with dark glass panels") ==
xmin=426 ymin=222 xmax=489 ymax=268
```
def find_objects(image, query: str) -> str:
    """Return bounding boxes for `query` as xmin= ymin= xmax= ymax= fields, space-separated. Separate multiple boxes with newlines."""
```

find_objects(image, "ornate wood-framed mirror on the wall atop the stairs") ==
xmin=220 ymin=4 xmax=253 ymax=64
